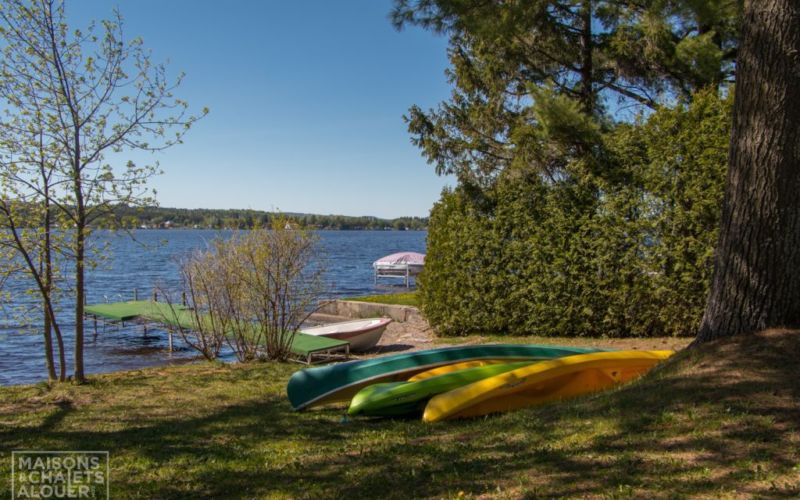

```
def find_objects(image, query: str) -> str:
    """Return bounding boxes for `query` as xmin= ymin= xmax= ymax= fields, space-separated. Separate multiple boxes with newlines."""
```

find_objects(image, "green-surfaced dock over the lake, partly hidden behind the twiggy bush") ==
xmin=84 ymin=300 xmax=350 ymax=364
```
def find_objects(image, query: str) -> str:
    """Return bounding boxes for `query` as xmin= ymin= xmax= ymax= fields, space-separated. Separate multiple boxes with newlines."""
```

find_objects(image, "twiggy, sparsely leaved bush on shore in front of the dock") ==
xmin=167 ymin=220 xmax=324 ymax=361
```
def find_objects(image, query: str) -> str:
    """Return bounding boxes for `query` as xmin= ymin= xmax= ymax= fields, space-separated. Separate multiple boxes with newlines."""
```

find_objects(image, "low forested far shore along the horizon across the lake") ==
xmin=107 ymin=206 xmax=428 ymax=231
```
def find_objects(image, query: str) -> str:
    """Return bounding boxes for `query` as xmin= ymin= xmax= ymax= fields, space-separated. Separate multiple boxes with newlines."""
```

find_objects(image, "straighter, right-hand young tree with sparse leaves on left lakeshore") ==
xmin=0 ymin=0 xmax=207 ymax=382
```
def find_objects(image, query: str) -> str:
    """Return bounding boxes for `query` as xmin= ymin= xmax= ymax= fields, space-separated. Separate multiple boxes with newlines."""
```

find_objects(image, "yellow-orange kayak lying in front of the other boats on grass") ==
xmin=422 ymin=351 xmax=674 ymax=422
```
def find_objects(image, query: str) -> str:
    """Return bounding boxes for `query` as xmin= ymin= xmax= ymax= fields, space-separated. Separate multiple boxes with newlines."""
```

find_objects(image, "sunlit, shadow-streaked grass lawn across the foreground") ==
xmin=0 ymin=332 xmax=800 ymax=498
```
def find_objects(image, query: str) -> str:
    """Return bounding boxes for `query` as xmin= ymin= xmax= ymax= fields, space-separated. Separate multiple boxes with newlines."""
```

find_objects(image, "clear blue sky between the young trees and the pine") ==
xmin=67 ymin=0 xmax=453 ymax=217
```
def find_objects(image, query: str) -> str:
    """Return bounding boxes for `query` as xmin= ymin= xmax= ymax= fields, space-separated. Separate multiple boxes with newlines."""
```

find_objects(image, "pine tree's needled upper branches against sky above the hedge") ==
xmin=392 ymin=0 xmax=739 ymax=189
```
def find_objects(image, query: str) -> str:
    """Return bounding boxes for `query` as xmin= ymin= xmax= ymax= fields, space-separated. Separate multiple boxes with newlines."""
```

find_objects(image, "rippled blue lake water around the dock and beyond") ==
xmin=0 ymin=230 xmax=426 ymax=385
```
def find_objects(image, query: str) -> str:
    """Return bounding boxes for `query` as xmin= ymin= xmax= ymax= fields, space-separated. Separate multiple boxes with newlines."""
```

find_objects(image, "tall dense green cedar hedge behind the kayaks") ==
xmin=420 ymin=90 xmax=731 ymax=336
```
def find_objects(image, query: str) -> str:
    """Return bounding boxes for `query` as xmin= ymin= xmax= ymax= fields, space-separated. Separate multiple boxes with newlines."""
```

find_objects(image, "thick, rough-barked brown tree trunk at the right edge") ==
xmin=695 ymin=0 xmax=800 ymax=342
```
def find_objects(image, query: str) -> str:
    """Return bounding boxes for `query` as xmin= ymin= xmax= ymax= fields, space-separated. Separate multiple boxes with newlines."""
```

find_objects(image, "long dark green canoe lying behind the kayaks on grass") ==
xmin=286 ymin=344 xmax=603 ymax=410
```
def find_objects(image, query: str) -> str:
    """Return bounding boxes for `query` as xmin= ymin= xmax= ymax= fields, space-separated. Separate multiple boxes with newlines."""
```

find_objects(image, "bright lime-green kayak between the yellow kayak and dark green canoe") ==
xmin=347 ymin=361 xmax=537 ymax=417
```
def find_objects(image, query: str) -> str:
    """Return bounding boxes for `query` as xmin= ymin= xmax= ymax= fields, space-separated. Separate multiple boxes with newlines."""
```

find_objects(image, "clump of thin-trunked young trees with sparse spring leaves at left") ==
xmin=0 ymin=0 xmax=208 ymax=382
